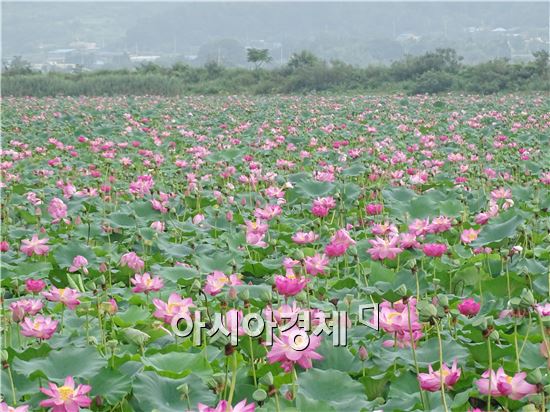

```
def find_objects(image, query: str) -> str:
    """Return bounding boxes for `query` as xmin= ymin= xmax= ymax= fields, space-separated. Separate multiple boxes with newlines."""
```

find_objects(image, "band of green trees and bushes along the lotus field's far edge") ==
xmin=2 ymin=49 xmax=550 ymax=96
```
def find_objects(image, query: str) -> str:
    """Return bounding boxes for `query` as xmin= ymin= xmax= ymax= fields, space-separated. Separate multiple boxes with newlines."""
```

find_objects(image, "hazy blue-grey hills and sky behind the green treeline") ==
xmin=2 ymin=2 xmax=549 ymax=65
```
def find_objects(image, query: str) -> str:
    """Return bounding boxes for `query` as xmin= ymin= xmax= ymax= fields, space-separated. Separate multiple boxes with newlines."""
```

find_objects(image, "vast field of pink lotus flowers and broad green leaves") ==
xmin=0 ymin=95 xmax=550 ymax=412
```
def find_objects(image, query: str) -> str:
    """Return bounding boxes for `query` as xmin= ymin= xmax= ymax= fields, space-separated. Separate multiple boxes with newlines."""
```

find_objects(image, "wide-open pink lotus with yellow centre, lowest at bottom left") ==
xmin=40 ymin=376 xmax=92 ymax=412
